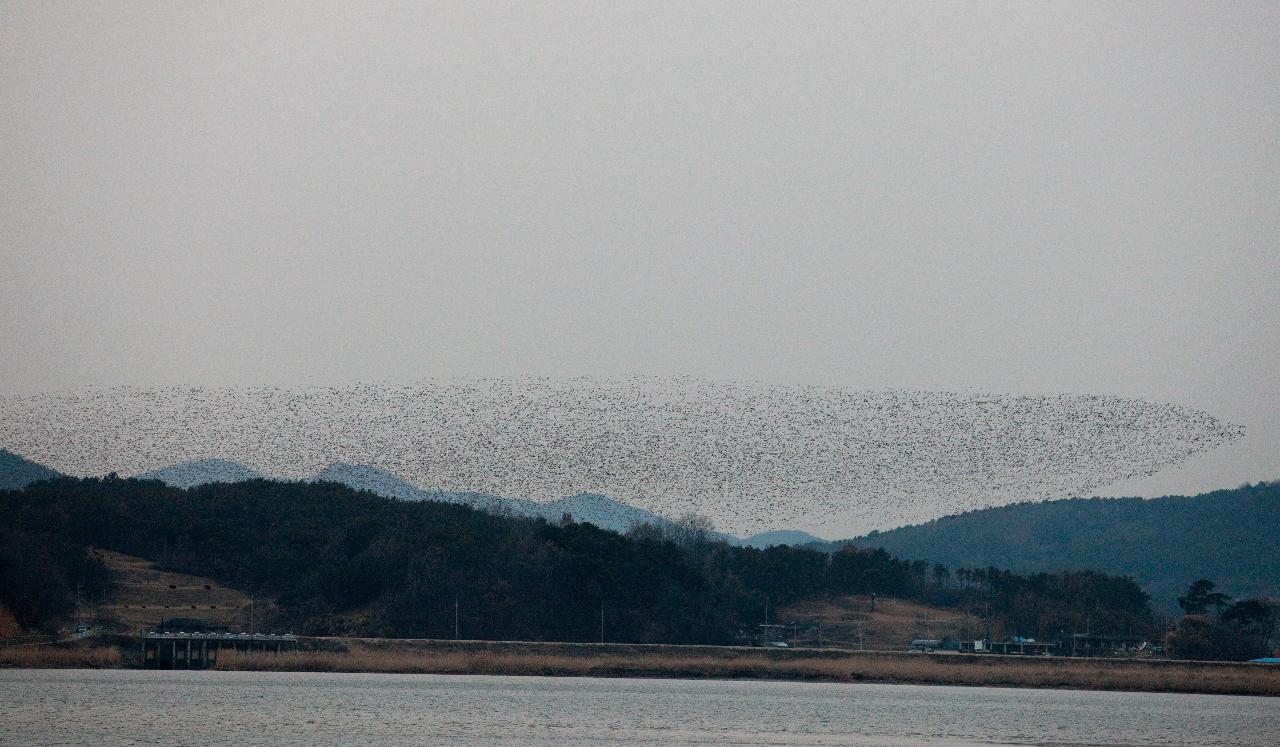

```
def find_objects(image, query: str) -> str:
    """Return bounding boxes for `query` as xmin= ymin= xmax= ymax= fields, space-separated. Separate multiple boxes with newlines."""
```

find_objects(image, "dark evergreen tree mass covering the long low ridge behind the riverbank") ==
xmin=0 ymin=477 xmax=1152 ymax=643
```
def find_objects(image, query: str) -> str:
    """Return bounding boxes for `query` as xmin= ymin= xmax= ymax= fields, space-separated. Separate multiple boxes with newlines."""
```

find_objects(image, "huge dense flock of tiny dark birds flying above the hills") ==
xmin=0 ymin=379 xmax=1243 ymax=532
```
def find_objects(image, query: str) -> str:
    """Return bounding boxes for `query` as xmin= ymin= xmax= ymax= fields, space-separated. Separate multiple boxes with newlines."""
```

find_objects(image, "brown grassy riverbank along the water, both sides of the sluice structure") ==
xmin=0 ymin=638 xmax=1280 ymax=697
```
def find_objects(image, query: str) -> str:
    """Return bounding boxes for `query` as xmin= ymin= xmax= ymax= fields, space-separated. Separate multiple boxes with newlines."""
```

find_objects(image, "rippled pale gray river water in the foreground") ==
xmin=0 ymin=669 xmax=1280 ymax=747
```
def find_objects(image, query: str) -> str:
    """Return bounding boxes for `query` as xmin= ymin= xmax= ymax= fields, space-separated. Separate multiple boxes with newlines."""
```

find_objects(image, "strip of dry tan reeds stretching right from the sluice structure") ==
xmin=218 ymin=650 xmax=1280 ymax=696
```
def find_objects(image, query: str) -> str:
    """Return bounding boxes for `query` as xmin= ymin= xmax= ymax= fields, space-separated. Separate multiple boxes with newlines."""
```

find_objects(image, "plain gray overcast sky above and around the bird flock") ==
xmin=0 ymin=1 xmax=1280 ymax=494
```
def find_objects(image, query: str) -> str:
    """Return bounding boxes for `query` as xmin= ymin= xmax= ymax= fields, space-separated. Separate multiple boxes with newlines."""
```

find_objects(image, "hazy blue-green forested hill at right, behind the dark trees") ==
xmin=850 ymin=482 xmax=1280 ymax=609
